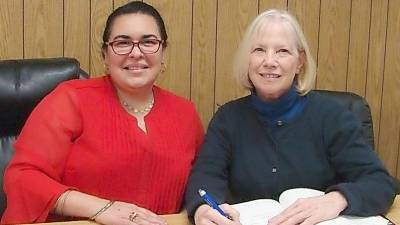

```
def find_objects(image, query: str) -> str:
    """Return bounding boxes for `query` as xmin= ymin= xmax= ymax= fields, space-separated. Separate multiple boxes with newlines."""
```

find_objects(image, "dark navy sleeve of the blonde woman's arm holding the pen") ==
xmin=185 ymin=106 xmax=230 ymax=218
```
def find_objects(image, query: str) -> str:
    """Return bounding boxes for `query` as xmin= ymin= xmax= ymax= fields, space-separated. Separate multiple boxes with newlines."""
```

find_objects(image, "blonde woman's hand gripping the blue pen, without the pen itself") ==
xmin=194 ymin=204 xmax=240 ymax=225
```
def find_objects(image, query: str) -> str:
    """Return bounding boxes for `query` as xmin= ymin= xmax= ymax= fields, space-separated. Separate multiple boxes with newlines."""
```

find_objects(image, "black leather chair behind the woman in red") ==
xmin=0 ymin=58 xmax=88 ymax=215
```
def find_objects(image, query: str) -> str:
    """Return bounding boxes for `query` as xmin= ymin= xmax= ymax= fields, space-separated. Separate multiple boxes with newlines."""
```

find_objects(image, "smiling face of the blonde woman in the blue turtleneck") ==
xmin=248 ymin=21 xmax=304 ymax=101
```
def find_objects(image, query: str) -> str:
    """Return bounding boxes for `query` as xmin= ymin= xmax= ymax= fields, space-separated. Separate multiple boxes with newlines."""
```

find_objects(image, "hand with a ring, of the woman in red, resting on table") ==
xmin=95 ymin=201 xmax=167 ymax=225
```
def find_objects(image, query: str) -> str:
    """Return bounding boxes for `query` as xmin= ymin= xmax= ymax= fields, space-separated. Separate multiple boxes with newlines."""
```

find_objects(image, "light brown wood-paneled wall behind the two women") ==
xmin=0 ymin=0 xmax=400 ymax=178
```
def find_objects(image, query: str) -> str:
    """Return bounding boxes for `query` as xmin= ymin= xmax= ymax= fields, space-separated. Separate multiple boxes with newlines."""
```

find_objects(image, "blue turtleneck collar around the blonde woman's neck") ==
xmin=251 ymin=85 xmax=307 ymax=126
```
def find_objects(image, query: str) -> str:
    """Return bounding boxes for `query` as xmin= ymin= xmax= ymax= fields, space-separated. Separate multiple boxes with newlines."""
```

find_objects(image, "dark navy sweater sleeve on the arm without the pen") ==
xmin=323 ymin=106 xmax=395 ymax=216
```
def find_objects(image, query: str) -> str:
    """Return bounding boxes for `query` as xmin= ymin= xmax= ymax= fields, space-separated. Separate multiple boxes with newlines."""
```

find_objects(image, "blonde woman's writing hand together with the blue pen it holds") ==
xmin=194 ymin=189 xmax=239 ymax=225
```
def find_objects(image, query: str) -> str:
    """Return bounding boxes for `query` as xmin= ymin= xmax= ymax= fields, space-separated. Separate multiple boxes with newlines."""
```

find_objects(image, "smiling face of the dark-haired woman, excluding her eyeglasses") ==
xmin=104 ymin=13 xmax=164 ymax=92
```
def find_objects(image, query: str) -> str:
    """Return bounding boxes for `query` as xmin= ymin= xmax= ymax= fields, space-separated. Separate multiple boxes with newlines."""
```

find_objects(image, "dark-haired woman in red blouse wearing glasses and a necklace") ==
xmin=1 ymin=2 xmax=203 ymax=225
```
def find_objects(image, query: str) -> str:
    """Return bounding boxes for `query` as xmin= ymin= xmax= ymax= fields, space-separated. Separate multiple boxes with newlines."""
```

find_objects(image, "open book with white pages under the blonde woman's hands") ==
xmin=232 ymin=188 xmax=389 ymax=225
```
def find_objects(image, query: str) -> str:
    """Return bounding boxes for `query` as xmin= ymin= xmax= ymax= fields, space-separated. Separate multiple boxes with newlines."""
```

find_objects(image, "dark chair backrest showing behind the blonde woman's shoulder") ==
xmin=315 ymin=90 xmax=374 ymax=148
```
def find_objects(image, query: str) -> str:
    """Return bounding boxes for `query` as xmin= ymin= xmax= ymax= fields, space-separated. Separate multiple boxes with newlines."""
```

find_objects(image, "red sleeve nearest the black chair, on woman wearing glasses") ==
xmin=1 ymin=85 xmax=82 ymax=224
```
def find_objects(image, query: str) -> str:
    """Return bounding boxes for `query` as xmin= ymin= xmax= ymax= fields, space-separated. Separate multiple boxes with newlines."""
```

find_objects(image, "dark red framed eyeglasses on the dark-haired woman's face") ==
xmin=105 ymin=39 xmax=163 ymax=55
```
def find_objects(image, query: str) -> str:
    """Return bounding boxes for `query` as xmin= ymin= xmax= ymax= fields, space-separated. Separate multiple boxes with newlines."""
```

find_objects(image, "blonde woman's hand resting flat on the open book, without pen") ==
xmin=268 ymin=191 xmax=347 ymax=225
